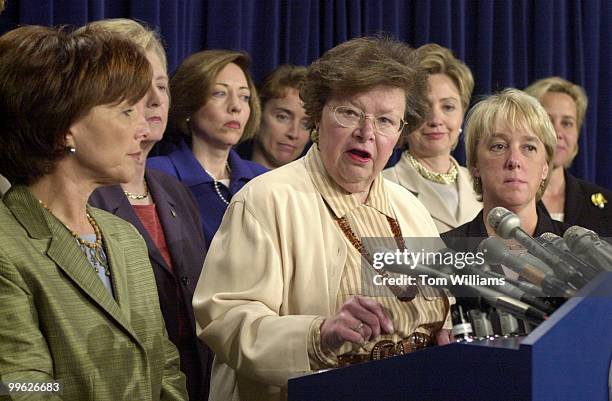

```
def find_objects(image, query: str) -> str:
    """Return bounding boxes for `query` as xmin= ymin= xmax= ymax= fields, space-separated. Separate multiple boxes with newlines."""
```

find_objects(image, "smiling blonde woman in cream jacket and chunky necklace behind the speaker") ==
xmin=383 ymin=43 xmax=482 ymax=232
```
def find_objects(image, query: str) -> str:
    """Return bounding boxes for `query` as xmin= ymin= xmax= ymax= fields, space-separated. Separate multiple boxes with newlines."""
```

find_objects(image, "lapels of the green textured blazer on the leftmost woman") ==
xmin=4 ymin=186 xmax=137 ymax=340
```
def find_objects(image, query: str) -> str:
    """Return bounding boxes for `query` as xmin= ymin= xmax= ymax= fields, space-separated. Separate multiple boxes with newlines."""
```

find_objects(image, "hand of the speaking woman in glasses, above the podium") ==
xmin=321 ymin=295 xmax=394 ymax=350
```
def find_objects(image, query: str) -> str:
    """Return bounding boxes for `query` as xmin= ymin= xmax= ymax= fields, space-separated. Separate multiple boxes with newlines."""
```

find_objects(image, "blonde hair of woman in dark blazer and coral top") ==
xmin=80 ymin=18 xmax=168 ymax=71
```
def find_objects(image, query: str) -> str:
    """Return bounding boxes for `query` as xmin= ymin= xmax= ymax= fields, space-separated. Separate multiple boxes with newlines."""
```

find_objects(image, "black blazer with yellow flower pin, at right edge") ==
xmin=563 ymin=171 xmax=612 ymax=237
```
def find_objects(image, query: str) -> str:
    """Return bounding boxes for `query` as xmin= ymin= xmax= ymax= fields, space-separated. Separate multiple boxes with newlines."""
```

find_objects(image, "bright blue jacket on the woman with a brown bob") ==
xmin=147 ymin=141 xmax=268 ymax=245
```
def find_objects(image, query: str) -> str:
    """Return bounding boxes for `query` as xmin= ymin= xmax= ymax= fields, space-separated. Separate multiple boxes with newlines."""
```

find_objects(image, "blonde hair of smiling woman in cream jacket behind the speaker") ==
xmin=416 ymin=43 xmax=474 ymax=113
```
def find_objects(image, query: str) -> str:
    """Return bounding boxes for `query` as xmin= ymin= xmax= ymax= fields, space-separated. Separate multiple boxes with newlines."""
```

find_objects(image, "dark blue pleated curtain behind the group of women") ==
xmin=0 ymin=0 xmax=612 ymax=188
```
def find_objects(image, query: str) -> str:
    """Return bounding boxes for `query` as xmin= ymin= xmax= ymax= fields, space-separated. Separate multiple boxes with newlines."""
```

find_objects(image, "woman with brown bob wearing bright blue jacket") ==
xmin=147 ymin=50 xmax=267 ymax=244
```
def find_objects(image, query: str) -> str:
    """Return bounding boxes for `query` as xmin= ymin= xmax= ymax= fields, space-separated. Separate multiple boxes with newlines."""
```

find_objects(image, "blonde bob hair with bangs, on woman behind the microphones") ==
xmin=465 ymin=88 xmax=557 ymax=200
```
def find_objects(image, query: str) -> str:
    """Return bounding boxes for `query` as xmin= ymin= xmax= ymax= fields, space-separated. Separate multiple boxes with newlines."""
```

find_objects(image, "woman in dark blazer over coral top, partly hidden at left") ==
xmin=88 ymin=19 xmax=212 ymax=400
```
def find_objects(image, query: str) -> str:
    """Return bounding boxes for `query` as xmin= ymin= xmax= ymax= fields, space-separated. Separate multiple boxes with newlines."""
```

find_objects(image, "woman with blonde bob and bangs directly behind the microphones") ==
xmin=442 ymin=89 xmax=564 ymax=251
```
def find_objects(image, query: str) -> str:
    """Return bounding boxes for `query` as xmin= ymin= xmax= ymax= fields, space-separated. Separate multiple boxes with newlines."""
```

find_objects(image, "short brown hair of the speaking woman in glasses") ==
xmin=300 ymin=36 xmax=429 ymax=134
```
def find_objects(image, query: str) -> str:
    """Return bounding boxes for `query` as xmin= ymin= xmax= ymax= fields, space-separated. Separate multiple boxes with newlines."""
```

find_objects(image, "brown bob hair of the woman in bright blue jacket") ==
xmin=170 ymin=50 xmax=261 ymax=141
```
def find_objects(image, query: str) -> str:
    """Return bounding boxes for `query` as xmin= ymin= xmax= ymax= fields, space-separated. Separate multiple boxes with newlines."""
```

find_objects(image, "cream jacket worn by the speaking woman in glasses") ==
xmin=193 ymin=154 xmax=448 ymax=401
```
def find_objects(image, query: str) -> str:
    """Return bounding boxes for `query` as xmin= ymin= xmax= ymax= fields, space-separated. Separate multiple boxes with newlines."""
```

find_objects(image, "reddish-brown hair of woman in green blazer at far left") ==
xmin=0 ymin=26 xmax=152 ymax=184
